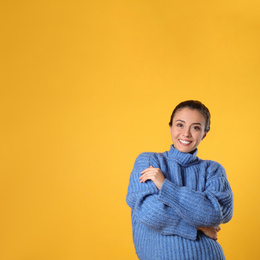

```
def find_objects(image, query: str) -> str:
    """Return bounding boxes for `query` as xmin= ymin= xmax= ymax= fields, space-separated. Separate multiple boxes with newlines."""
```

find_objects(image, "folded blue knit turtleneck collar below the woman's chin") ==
xmin=168 ymin=145 xmax=199 ymax=165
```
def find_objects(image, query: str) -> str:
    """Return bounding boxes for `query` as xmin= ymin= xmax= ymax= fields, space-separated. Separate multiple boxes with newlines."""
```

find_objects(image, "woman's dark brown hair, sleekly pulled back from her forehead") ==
xmin=169 ymin=100 xmax=210 ymax=132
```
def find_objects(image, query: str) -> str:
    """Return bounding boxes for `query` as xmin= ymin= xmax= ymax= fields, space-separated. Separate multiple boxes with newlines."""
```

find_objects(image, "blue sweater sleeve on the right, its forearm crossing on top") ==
xmin=158 ymin=162 xmax=233 ymax=227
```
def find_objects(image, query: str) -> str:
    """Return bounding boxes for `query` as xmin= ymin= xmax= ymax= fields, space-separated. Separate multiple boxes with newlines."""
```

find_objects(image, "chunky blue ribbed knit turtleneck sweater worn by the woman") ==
xmin=126 ymin=146 xmax=233 ymax=260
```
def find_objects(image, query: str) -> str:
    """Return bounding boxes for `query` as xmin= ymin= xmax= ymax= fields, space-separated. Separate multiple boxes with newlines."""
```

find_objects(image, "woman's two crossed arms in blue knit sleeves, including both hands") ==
xmin=127 ymin=154 xmax=232 ymax=239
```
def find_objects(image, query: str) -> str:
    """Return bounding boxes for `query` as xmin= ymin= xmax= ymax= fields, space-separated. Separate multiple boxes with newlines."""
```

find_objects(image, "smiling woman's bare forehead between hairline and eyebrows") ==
xmin=173 ymin=108 xmax=206 ymax=124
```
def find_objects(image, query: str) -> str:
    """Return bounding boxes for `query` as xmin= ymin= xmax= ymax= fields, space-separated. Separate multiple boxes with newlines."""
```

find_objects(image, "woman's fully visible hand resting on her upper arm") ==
xmin=139 ymin=166 xmax=165 ymax=190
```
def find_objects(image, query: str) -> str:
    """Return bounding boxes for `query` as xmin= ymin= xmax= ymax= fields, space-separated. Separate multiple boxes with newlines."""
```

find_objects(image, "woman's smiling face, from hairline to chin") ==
xmin=170 ymin=108 xmax=207 ymax=153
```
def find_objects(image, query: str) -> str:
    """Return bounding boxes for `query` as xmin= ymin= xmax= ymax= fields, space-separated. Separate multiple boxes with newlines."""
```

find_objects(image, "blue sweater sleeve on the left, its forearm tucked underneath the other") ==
xmin=126 ymin=153 xmax=197 ymax=240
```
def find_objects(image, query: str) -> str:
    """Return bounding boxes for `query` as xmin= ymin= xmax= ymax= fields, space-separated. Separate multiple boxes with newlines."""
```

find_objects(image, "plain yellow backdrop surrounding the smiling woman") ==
xmin=0 ymin=0 xmax=260 ymax=260
